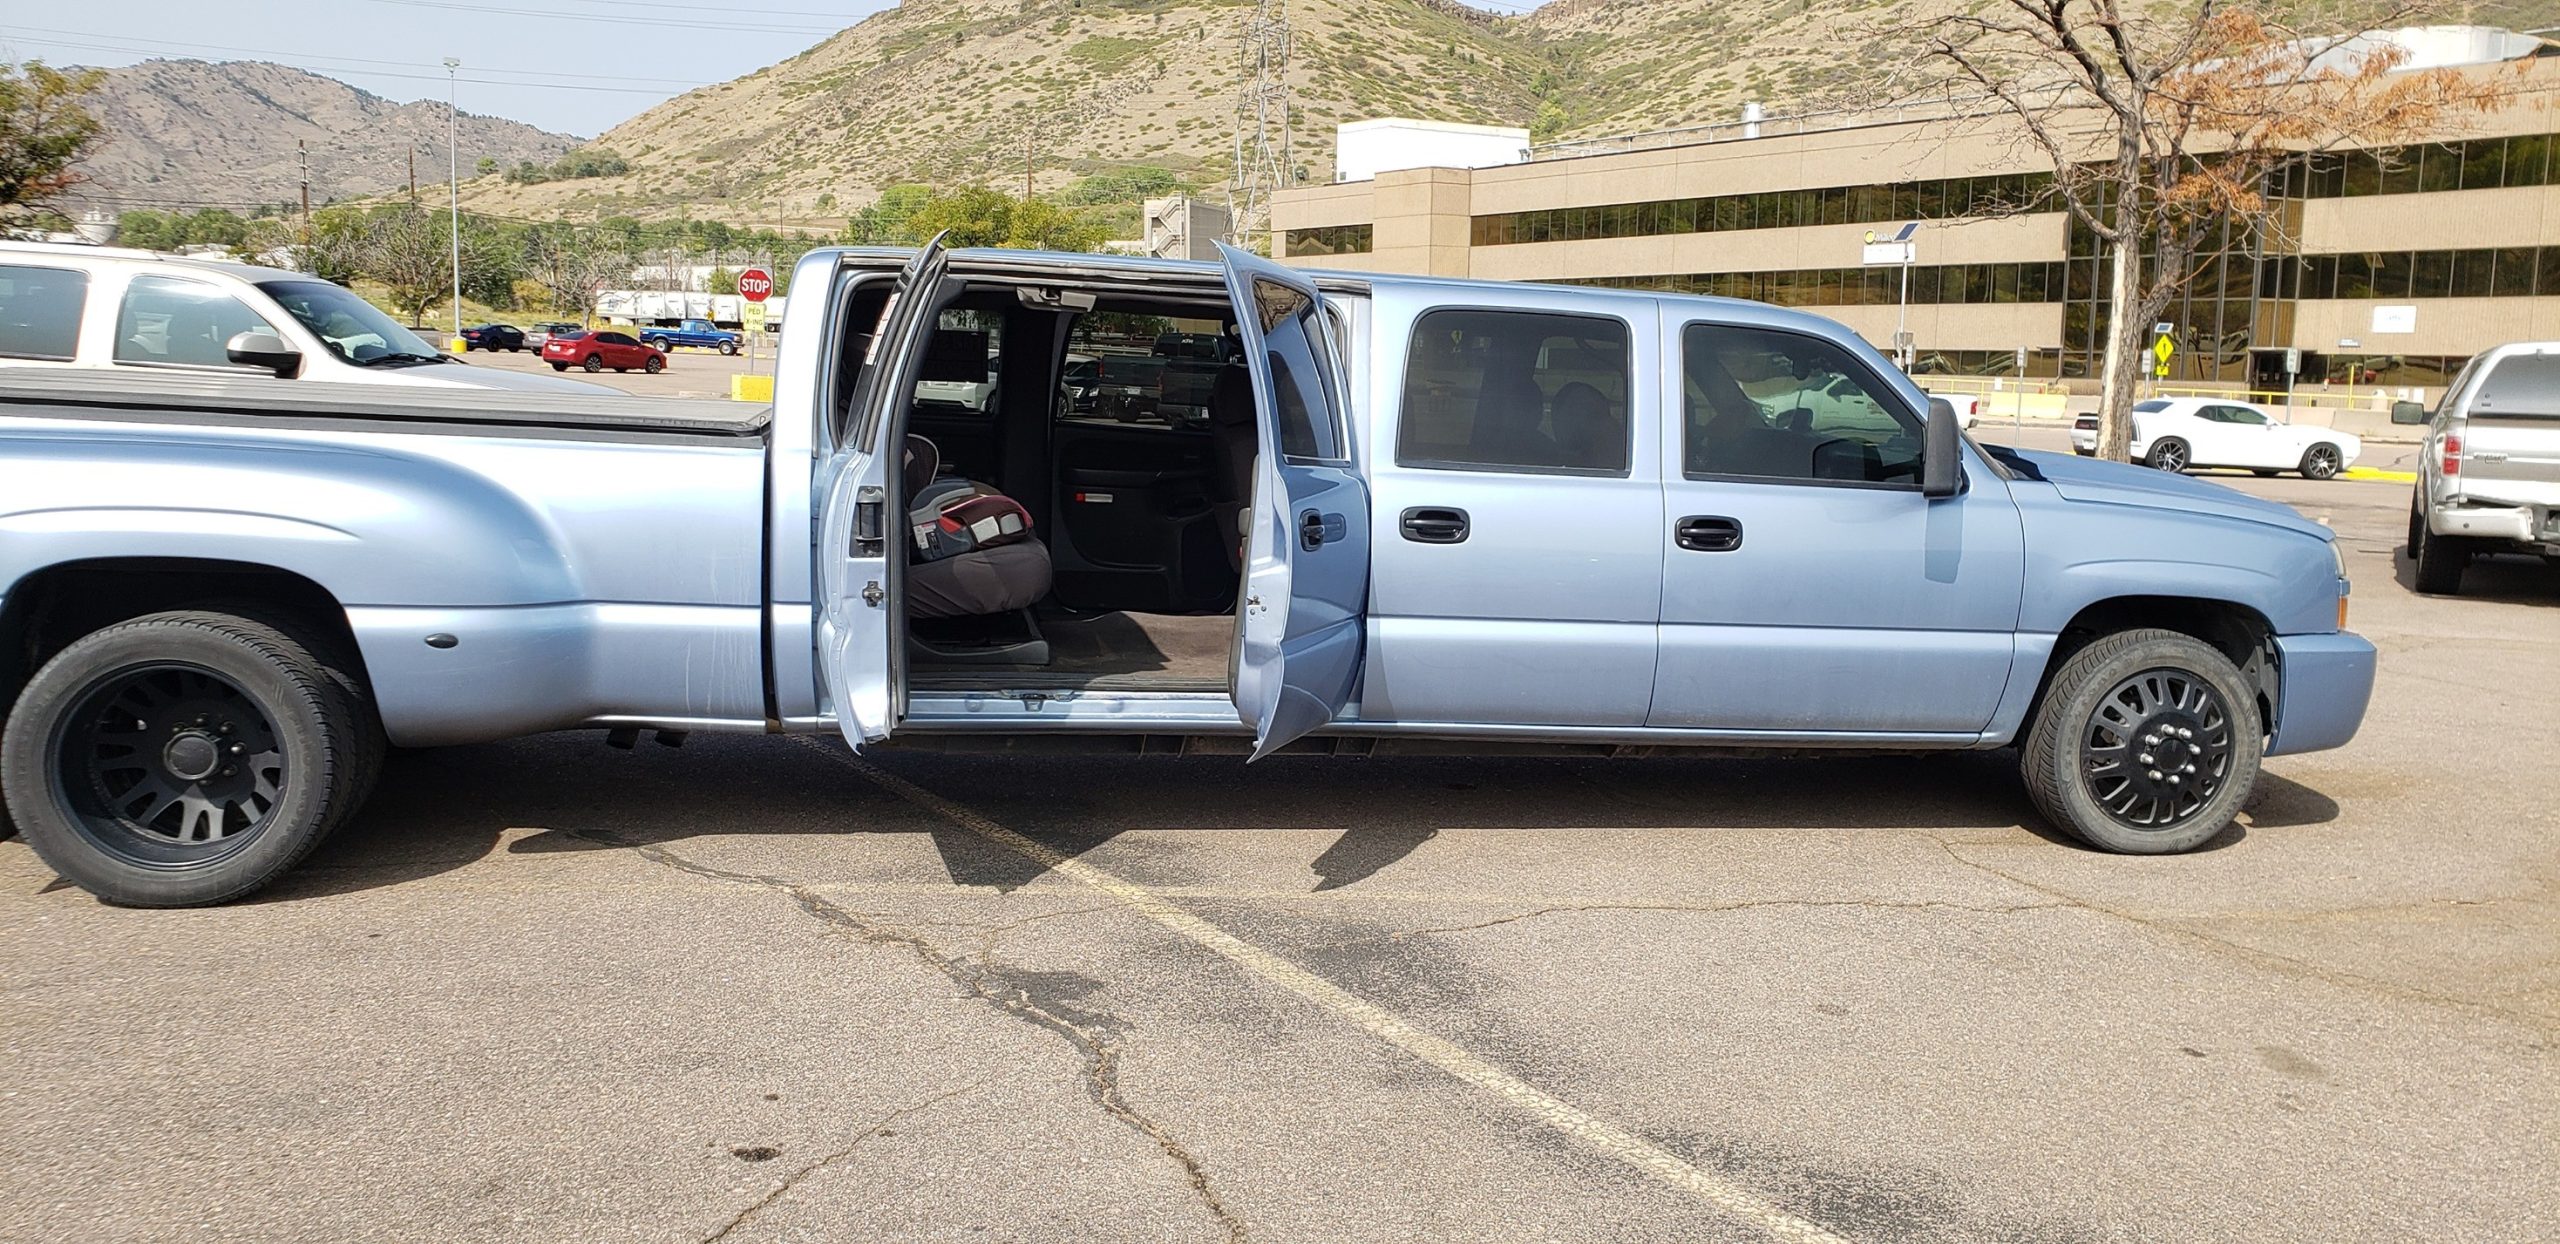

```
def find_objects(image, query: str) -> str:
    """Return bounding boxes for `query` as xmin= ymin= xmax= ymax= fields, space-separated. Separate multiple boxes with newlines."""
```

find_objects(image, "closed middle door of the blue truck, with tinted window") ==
xmin=1359 ymin=299 xmax=1667 ymax=727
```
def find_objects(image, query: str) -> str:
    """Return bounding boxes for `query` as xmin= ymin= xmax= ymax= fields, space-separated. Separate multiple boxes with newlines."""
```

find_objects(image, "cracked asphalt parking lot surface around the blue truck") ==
xmin=0 ymin=458 xmax=2560 ymax=1241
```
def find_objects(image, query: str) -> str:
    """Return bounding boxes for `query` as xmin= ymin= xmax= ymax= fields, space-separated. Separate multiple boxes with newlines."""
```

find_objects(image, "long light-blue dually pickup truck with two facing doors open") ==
xmin=0 ymin=246 xmax=2373 ymax=906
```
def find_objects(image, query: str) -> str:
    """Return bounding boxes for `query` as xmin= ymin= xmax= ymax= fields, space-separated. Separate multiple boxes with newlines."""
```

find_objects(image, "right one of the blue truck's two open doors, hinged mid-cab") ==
xmin=1219 ymin=246 xmax=1370 ymax=758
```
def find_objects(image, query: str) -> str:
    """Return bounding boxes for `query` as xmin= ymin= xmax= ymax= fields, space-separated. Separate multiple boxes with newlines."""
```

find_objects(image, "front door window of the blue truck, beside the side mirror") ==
xmin=1679 ymin=325 xmax=1920 ymax=486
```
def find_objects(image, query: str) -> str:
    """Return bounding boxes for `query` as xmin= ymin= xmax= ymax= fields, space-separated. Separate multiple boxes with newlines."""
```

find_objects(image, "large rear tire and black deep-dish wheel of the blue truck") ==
xmin=0 ymin=612 xmax=364 ymax=906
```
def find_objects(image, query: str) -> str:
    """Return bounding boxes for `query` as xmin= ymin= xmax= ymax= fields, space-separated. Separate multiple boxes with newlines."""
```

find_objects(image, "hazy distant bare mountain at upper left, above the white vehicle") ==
xmin=82 ymin=61 xmax=576 ymax=207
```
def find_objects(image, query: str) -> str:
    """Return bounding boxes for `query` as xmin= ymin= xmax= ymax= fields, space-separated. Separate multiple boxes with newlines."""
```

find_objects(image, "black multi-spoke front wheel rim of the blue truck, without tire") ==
xmin=2081 ymin=668 xmax=2232 ymax=829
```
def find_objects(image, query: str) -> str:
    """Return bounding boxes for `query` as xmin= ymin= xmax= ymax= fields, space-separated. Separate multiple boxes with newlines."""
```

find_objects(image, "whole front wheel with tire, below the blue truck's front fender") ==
xmin=2020 ymin=630 xmax=2266 ymax=855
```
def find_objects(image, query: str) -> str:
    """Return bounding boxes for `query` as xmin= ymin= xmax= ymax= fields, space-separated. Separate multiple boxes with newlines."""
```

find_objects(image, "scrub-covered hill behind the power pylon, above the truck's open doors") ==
xmin=453 ymin=0 xmax=1546 ymax=212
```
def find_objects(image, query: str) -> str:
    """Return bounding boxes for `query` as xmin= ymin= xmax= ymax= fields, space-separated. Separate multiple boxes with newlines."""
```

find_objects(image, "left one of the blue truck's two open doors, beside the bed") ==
xmin=808 ymin=238 xmax=950 ymax=750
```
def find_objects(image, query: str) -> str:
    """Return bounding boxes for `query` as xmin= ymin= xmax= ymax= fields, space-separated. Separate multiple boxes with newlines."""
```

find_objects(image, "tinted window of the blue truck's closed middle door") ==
xmin=1395 ymin=310 xmax=1628 ymax=476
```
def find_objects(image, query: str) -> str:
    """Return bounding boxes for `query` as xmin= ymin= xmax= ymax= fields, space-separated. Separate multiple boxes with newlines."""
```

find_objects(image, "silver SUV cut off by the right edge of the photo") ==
xmin=2391 ymin=340 xmax=2560 ymax=594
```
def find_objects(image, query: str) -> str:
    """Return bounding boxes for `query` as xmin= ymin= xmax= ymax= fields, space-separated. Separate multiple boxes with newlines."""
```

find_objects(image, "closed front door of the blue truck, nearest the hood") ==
xmin=1649 ymin=323 xmax=2025 ymax=735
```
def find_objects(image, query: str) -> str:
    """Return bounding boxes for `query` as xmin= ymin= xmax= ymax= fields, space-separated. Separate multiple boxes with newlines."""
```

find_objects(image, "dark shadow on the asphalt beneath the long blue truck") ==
xmin=261 ymin=735 xmax=2340 ymax=901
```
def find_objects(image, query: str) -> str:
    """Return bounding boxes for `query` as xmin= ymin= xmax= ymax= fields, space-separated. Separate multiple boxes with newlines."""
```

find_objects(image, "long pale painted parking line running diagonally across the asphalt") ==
xmin=794 ymin=737 xmax=1846 ymax=1244
